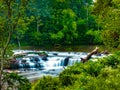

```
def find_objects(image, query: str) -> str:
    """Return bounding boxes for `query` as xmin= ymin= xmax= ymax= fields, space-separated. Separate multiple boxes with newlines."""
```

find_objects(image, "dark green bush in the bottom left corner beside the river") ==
xmin=3 ymin=73 xmax=31 ymax=90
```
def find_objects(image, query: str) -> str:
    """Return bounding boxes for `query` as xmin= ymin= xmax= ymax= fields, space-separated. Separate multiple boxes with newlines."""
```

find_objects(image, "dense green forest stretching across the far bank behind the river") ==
xmin=3 ymin=0 xmax=120 ymax=47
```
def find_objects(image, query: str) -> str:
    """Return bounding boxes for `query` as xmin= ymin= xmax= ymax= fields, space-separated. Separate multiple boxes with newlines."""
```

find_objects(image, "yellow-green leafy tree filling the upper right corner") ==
xmin=94 ymin=0 xmax=120 ymax=47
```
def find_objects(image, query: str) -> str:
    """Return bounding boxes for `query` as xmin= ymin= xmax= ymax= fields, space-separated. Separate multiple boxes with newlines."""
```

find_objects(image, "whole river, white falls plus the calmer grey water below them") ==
xmin=10 ymin=50 xmax=105 ymax=80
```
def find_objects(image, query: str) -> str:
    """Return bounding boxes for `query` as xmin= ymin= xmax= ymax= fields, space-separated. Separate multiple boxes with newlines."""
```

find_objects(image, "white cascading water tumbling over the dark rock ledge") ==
xmin=11 ymin=50 xmax=106 ymax=69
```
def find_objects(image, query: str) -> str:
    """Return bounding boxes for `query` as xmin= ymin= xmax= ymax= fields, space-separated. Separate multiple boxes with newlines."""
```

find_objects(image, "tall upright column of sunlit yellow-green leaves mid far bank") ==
xmin=62 ymin=9 xmax=77 ymax=44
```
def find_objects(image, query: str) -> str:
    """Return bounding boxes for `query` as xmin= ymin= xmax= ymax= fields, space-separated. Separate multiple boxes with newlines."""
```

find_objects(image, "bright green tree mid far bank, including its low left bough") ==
xmin=51 ymin=9 xmax=77 ymax=44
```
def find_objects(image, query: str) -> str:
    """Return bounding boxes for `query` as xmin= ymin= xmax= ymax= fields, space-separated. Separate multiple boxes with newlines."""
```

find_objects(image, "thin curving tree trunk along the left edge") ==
xmin=0 ymin=0 xmax=13 ymax=87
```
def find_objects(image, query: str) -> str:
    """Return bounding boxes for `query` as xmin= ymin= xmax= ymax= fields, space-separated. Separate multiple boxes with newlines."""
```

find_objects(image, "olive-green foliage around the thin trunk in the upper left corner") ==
xmin=0 ymin=0 xmax=32 ymax=53
